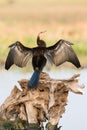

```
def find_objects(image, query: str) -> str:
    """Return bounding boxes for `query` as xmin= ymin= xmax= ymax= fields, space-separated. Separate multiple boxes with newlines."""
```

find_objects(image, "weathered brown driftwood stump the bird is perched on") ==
xmin=0 ymin=73 xmax=84 ymax=130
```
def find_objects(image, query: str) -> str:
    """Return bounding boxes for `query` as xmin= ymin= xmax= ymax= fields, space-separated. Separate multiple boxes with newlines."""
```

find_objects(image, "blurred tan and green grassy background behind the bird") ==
xmin=0 ymin=0 xmax=87 ymax=65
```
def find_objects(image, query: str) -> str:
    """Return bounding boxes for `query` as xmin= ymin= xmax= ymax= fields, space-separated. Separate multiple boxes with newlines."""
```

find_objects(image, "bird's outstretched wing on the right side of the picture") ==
xmin=45 ymin=40 xmax=81 ymax=68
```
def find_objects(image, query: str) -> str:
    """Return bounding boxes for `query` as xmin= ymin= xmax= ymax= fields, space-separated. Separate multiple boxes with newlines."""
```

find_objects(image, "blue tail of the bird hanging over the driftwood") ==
xmin=28 ymin=70 xmax=40 ymax=89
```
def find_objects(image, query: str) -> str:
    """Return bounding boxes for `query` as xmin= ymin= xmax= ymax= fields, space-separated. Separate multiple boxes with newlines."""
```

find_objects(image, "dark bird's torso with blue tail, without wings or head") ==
xmin=28 ymin=47 xmax=47 ymax=88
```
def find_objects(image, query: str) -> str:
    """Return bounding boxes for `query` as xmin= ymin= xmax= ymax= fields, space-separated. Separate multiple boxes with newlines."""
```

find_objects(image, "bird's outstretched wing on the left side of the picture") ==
xmin=5 ymin=41 xmax=32 ymax=70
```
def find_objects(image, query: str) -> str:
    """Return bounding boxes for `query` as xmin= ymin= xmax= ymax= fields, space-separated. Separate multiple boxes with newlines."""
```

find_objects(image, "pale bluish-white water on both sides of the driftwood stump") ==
xmin=0 ymin=69 xmax=87 ymax=130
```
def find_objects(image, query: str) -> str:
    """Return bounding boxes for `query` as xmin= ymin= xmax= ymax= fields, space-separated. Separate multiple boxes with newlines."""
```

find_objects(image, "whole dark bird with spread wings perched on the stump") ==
xmin=5 ymin=32 xmax=81 ymax=89
